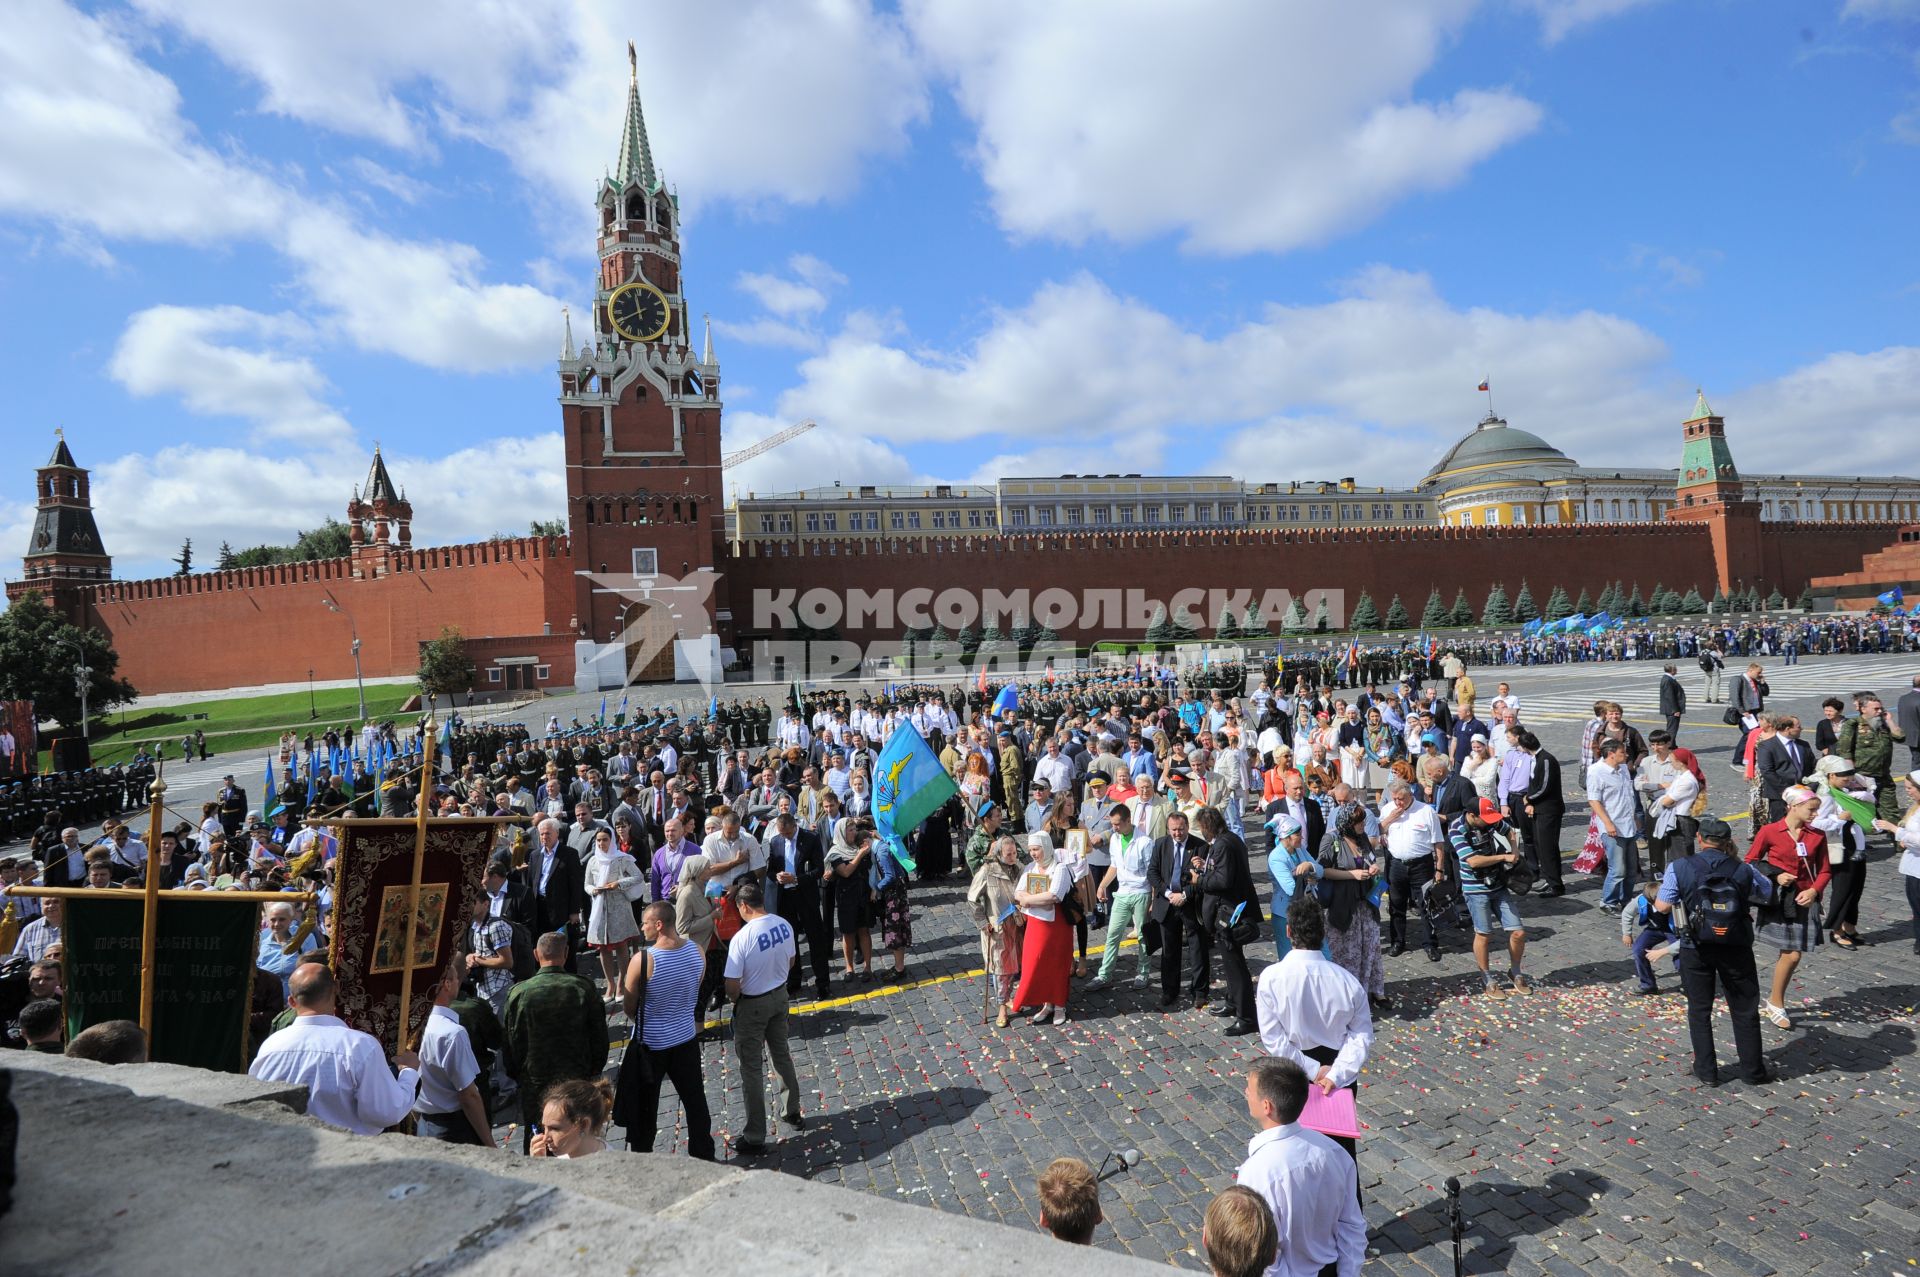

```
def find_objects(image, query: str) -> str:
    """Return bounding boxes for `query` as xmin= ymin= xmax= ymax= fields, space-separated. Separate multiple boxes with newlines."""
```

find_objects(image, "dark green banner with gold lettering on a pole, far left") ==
xmin=61 ymin=891 xmax=259 ymax=1072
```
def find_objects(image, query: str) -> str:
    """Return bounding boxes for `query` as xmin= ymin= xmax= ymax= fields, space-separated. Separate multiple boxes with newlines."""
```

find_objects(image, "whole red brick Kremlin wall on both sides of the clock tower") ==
xmin=33 ymin=522 xmax=1897 ymax=693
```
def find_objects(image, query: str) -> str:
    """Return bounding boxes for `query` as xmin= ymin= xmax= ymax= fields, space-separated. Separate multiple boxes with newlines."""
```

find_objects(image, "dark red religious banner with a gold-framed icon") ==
xmin=328 ymin=816 xmax=499 ymax=1050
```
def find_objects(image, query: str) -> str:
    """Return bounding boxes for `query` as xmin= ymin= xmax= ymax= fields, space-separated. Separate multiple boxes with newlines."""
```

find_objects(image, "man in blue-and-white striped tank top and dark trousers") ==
xmin=614 ymin=901 xmax=714 ymax=1162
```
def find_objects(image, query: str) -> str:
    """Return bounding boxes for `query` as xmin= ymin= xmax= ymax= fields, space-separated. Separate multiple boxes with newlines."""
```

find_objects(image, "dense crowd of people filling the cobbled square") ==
xmin=11 ymin=637 xmax=1920 ymax=1273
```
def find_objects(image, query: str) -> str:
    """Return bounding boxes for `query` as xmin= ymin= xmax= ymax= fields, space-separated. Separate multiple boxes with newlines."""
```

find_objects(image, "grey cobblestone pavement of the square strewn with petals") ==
xmin=579 ymin=659 xmax=1920 ymax=1275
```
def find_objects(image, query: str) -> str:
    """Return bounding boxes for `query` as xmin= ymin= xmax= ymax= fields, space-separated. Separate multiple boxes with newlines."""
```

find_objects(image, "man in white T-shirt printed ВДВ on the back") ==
xmin=722 ymin=878 xmax=806 ymax=1154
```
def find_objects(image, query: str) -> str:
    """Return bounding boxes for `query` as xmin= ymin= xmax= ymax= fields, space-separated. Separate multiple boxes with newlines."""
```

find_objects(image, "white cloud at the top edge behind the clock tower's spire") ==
xmin=123 ymin=0 xmax=927 ymax=246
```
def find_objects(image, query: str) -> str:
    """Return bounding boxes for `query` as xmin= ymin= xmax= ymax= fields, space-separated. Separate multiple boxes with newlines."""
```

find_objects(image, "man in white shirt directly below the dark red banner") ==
xmin=248 ymin=962 xmax=420 ymax=1135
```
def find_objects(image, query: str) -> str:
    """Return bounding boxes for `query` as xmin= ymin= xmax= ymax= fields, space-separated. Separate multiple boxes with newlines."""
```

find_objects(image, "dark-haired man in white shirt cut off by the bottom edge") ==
xmin=1236 ymin=1058 xmax=1367 ymax=1277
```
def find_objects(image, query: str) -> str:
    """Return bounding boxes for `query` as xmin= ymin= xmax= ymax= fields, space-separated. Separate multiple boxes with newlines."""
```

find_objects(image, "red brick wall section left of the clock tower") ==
xmin=86 ymin=536 xmax=574 ymax=693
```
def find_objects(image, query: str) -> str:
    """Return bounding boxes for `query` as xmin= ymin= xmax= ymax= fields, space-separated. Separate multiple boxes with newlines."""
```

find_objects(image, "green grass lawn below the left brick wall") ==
xmin=40 ymin=684 xmax=417 ymax=766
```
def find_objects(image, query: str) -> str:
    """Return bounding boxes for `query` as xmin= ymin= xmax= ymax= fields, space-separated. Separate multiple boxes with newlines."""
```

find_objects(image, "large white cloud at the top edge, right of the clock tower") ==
xmin=906 ymin=0 xmax=1540 ymax=253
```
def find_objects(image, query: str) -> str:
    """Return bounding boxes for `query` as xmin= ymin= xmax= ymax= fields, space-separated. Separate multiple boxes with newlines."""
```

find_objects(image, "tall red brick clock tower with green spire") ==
xmin=559 ymin=42 xmax=726 ymax=687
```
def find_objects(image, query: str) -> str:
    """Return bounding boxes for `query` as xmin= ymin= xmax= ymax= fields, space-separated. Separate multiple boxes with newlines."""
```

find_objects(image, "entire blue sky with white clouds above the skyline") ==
xmin=0 ymin=0 xmax=1920 ymax=576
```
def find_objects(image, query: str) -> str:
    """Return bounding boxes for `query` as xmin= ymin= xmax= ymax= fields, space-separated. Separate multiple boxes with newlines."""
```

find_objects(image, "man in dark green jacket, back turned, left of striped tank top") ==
xmin=507 ymin=931 xmax=607 ymax=1152
